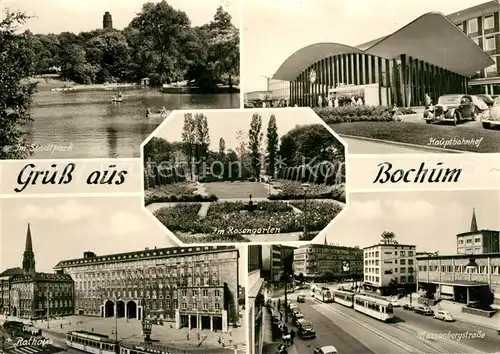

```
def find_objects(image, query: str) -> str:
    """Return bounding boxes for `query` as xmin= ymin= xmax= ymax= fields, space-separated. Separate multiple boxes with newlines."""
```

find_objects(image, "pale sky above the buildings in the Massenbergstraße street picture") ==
xmin=314 ymin=191 xmax=500 ymax=255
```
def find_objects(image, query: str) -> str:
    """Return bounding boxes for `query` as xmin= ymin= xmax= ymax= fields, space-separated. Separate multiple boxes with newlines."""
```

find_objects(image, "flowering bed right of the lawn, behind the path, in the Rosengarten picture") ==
xmin=268 ymin=180 xmax=345 ymax=203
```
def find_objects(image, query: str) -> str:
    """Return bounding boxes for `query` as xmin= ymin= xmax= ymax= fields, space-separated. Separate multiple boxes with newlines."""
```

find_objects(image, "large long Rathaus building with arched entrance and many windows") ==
xmin=55 ymin=246 xmax=239 ymax=332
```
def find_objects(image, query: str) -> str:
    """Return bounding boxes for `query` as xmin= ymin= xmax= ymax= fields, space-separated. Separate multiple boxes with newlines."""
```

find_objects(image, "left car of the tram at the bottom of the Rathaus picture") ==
xmin=66 ymin=331 xmax=119 ymax=354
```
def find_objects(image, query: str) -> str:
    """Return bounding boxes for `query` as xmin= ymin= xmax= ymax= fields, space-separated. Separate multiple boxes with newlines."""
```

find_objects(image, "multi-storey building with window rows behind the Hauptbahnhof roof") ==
xmin=448 ymin=1 xmax=500 ymax=95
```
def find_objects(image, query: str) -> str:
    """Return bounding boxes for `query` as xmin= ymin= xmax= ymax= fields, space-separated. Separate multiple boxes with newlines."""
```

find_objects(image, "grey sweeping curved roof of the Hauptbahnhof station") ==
xmin=273 ymin=12 xmax=494 ymax=81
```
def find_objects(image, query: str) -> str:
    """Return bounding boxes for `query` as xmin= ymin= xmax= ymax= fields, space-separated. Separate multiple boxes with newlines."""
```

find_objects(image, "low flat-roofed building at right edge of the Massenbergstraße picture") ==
xmin=417 ymin=253 xmax=500 ymax=304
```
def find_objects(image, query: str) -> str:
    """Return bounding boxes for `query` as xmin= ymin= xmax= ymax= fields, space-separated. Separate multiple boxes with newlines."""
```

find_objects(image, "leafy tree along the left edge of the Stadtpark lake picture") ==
xmin=0 ymin=10 xmax=36 ymax=159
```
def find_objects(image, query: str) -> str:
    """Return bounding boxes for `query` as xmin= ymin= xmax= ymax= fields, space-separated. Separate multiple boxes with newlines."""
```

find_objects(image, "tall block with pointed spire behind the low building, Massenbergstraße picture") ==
xmin=457 ymin=210 xmax=500 ymax=254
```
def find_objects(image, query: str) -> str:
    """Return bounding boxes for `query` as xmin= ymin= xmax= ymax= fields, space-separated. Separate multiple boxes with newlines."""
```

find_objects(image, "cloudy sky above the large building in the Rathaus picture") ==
xmin=0 ymin=196 xmax=247 ymax=285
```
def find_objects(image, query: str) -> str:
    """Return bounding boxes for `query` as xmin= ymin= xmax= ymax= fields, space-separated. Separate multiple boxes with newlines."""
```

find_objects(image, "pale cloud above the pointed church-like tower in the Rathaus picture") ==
xmin=19 ymin=200 xmax=96 ymax=224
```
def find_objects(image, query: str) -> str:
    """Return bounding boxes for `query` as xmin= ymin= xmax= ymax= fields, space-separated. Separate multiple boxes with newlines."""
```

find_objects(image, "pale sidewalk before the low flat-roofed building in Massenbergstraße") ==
xmin=398 ymin=293 xmax=500 ymax=330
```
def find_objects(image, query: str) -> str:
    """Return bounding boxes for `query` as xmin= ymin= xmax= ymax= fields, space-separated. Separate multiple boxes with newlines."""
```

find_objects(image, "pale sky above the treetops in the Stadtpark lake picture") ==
xmin=0 ymin=0 xmax=241 ymax=34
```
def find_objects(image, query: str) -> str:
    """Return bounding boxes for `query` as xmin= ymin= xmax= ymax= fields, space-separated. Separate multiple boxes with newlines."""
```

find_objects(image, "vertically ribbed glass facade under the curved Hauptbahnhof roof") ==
xmin=290 ymin=52 xmax=467 ymax=107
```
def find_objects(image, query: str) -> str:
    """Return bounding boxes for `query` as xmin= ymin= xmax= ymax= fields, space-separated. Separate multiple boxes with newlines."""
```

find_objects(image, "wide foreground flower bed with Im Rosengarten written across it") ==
xmin=154 ymin=200 xmax=343 ymax=242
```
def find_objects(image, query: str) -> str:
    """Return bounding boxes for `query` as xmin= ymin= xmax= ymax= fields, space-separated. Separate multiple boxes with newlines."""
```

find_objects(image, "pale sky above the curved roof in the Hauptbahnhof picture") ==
xmin=241 ymin=0 xmax=487 ymax=92
